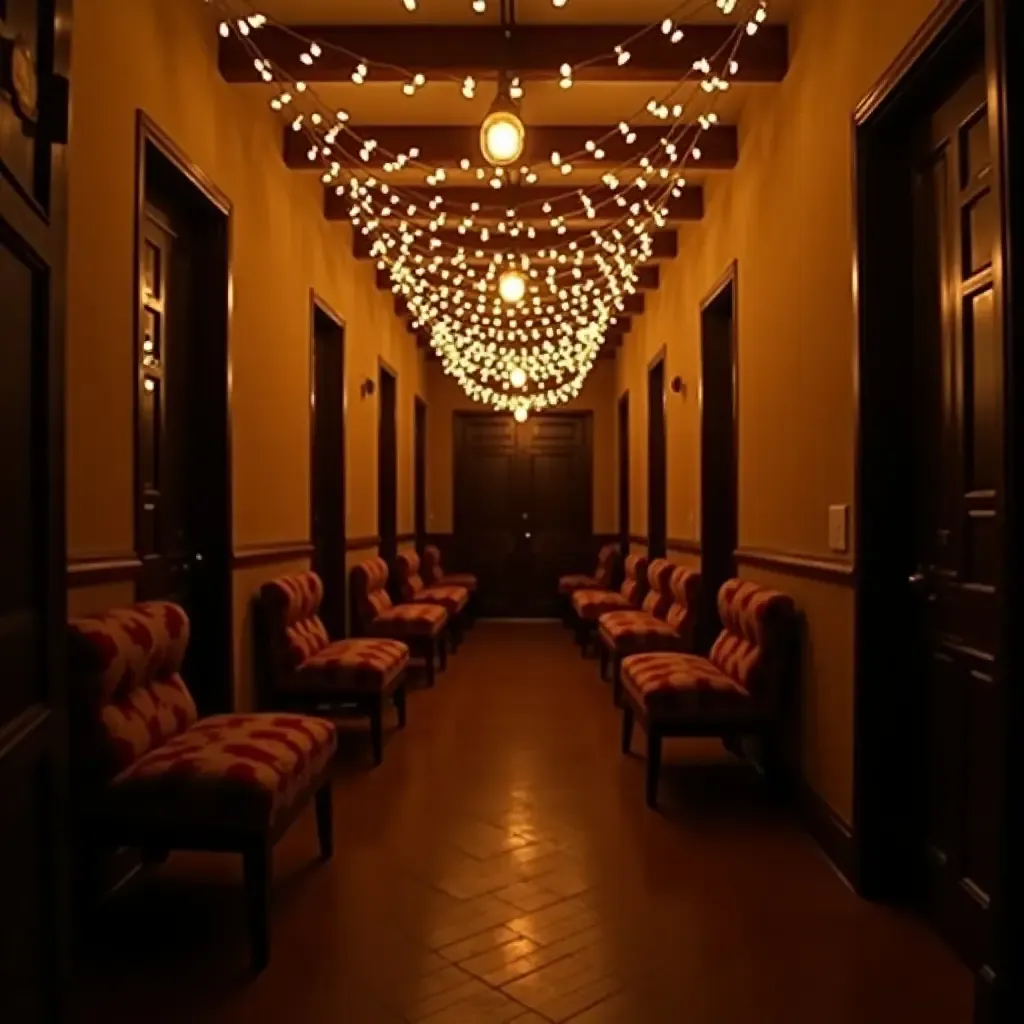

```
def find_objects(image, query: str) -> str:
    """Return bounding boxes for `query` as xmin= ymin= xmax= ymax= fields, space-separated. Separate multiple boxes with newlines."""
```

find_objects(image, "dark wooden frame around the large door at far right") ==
xmin=851 ymin=0 xmax=1024 ymax=1021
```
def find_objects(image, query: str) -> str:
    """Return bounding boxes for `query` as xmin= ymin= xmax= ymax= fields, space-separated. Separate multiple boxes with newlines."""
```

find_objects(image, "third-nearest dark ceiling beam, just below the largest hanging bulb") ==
xmin=324 ymin=185 xmax=703 ymax=227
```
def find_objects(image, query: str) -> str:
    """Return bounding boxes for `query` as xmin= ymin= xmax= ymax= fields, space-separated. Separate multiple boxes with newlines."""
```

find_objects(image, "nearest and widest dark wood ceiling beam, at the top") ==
xmin=219 ymin=25 xmax=788 ymax=82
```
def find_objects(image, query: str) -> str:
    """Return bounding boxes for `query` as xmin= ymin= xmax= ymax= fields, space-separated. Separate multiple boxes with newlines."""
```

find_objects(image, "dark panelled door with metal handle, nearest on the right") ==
xmin=908 ymin=69 xmax=1004 ymax=966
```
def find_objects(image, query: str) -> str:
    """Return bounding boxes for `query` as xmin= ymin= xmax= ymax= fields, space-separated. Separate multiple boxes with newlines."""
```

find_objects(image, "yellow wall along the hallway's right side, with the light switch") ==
xmin=617 ymin=0 xmax=935 ymax=820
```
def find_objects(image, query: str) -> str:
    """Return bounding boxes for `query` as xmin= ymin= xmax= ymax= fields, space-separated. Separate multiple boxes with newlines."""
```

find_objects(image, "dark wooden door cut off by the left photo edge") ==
xmin=0 ymin=0 xmax=71 ymax=1024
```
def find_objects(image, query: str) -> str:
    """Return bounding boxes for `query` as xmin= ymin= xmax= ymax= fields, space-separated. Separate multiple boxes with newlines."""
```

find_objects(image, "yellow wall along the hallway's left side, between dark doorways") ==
xmin=68 ymin=0 xmax=423 ymax=705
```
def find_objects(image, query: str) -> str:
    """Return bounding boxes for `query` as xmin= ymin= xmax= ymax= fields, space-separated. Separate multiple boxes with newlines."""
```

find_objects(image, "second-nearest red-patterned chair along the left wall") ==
xmin=259 ymin=572 xmax=410 ymax=764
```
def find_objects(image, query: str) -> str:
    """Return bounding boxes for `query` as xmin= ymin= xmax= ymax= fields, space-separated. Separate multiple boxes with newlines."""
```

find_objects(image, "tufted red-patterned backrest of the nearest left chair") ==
xmin=68 ymin=601 xmax=198 ymax=781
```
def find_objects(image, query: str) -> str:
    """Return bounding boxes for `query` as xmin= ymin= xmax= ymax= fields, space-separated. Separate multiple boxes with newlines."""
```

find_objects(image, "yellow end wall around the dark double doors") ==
xmin=426 ymin=359 xmax=618 ymax=534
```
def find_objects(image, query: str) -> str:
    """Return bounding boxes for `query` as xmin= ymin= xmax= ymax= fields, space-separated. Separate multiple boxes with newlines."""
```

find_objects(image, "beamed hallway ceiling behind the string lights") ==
xmin=214 ymin=0 xmax=799 ymax=376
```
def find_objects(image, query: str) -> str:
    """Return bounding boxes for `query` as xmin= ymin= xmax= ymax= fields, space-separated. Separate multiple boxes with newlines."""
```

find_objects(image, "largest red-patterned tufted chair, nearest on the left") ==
xmin=69 ymin=602 xmax=336 ymax=972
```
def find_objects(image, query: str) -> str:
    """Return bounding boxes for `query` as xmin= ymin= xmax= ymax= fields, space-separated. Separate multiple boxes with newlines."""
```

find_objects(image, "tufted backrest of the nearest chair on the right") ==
xmin=709 ymin=580 xmax=797 ymax=700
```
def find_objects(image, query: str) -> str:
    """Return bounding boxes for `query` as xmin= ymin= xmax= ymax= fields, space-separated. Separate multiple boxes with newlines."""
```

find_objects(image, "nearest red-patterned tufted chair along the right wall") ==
xmin=622 ymin=580 xmax=797 ymax=807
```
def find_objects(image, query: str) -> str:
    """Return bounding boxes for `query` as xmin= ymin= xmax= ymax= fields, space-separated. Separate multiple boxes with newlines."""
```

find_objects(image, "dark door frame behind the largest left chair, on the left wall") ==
xmin=131 ymin=109 xmax=234 ymax=710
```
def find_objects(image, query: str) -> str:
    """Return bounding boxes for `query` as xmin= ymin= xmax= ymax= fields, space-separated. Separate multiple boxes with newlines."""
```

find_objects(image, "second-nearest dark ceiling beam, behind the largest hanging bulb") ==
xmin=285 ymin=125 xmax=739 ymax=171
